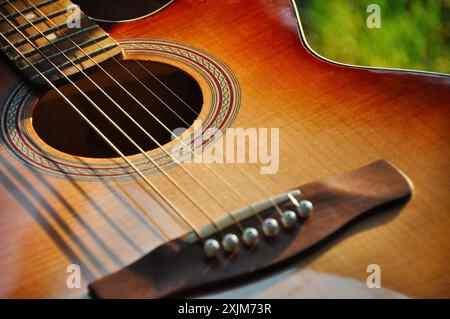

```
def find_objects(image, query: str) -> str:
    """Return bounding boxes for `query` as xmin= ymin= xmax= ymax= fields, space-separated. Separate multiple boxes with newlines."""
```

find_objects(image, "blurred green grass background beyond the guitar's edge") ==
xmin=296 ymin=0 xmax=450 ymax=73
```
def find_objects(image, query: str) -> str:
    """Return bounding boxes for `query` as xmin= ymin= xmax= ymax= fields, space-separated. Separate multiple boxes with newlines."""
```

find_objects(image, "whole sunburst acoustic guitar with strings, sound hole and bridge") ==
xmin=0 ymin=0 xmax=450 ymax=298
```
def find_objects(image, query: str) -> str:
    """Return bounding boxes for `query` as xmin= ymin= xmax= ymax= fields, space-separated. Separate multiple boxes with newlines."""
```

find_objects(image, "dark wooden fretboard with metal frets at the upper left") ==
xmin=0 ymin=0 xmax=121 ymax=84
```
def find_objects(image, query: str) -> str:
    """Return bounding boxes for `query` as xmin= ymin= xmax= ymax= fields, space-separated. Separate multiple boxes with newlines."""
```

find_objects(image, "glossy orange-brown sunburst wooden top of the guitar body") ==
xmin=0 ymin=0 xmax=450 ymax=298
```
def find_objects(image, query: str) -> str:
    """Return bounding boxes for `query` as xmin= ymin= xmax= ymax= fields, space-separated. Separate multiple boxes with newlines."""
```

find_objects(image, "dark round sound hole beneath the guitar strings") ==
xmin=32 ymin=60 xmax=203 ymax=158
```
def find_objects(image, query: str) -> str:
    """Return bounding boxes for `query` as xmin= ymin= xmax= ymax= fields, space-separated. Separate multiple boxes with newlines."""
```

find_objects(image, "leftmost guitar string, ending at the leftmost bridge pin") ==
xmin=0 ymin=7 xmax=203 ymax=240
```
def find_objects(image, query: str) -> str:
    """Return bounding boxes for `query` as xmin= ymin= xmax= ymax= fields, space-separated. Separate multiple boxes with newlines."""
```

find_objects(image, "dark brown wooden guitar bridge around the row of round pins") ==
xmin=90 ymin=161 xmax=412 ymax=298
